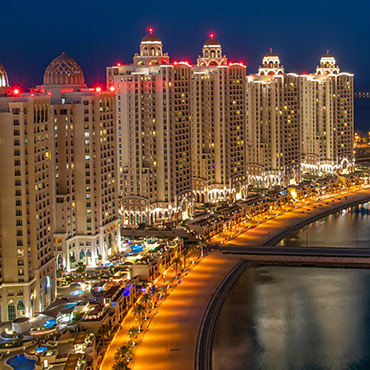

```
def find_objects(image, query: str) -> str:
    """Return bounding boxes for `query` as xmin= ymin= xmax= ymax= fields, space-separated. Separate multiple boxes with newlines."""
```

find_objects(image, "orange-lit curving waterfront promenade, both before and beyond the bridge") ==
xmin=120 ymin=189 xmax=370 ymax=370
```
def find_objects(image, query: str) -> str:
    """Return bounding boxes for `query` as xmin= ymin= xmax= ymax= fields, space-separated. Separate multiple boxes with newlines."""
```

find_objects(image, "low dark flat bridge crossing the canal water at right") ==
xmin=214 ymin=244 xmax=370 ymax=268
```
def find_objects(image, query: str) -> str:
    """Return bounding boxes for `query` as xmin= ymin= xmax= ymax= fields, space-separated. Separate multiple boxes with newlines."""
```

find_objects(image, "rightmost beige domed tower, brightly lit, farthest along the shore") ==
xmin=300 ymin=53 xmax=354 ymax=175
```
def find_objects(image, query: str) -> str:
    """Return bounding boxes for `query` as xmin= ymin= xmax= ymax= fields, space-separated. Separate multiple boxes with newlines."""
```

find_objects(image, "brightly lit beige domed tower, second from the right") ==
xmin=246 ymin=51 xmax=301 ymax=188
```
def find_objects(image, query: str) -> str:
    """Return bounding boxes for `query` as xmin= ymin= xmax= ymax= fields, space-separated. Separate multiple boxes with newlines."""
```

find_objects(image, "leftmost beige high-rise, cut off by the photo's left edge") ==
xmin=0 ymin=65 xmax=56 ymax=321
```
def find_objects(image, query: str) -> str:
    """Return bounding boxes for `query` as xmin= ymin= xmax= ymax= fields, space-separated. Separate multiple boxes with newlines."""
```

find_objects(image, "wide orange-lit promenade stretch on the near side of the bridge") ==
xmin=131 ymin=252 xmax=238 ymax=370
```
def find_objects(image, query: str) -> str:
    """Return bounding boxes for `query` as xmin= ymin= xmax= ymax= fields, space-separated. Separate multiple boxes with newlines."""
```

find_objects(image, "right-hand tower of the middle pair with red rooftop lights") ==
xmin=191 ymin=34 xmax=247 ymax=203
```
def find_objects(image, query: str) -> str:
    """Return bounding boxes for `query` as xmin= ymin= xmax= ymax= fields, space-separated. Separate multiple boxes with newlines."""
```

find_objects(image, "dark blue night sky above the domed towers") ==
xmin=0 ymin=0 xmax=370 ymax=91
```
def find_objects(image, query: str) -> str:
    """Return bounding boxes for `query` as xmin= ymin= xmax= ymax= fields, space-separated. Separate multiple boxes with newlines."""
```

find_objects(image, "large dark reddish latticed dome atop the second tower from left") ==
xmin=44 ymin=53 xmax=85 ymax=86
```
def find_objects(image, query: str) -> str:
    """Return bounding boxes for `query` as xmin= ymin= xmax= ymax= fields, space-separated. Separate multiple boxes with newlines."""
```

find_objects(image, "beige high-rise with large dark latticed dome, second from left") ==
xmin=42 ymin=53 xmax=120 ymax=271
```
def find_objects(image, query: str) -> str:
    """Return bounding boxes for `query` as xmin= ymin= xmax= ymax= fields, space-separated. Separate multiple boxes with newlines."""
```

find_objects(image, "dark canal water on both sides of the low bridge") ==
xmin=212 ymin=204 xmax=370 ymax=370
